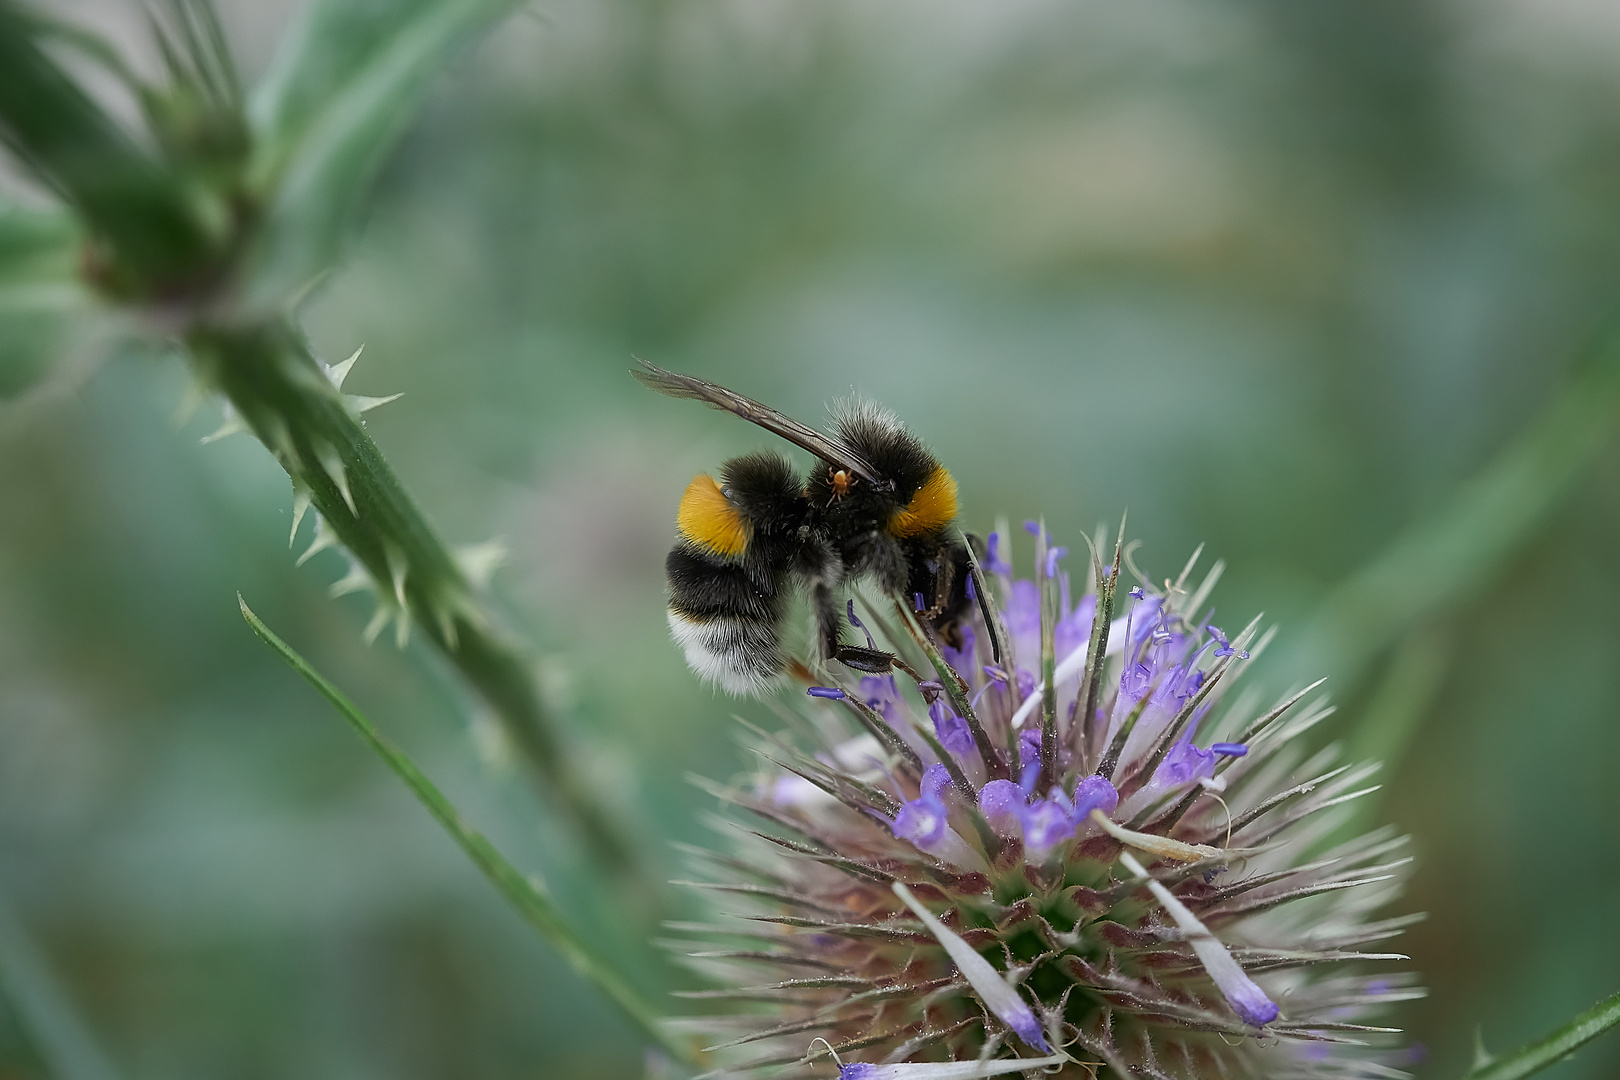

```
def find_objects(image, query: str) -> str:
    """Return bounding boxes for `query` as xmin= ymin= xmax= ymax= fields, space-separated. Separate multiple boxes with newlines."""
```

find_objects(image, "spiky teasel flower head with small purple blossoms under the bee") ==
xmin=669 ymin=523 xmax=1422 ymax=1080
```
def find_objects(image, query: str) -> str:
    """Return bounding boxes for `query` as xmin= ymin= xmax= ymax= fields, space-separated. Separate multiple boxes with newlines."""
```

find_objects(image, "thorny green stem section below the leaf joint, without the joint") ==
xmin=185 ymin=321 xmax=633 ymax=871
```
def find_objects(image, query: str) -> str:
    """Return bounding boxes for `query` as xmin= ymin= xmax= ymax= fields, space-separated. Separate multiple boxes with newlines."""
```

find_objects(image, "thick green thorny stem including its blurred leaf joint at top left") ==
xmin=0 ymin=0 xmax=632 ymax=870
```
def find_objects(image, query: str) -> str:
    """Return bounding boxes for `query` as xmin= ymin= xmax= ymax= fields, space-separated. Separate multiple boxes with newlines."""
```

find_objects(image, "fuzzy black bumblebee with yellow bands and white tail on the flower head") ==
xmin=632 ymin=361 xmax=1000 ymax=695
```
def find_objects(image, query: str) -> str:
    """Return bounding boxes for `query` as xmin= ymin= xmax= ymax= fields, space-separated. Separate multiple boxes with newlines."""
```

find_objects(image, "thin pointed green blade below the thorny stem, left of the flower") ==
xmin=237 ymin=593 xmax=692 ymax=1061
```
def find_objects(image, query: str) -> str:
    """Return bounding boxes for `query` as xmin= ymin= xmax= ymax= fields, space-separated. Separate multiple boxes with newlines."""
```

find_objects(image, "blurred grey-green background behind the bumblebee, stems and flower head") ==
xmin=0 ymin=0 xmax=1620 ymax=1080
